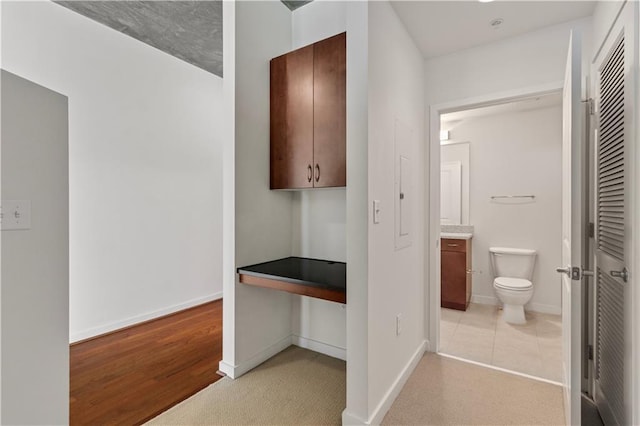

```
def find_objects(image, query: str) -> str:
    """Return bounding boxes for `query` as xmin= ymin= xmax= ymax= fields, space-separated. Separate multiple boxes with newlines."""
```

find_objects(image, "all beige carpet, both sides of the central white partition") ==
xmin=148 ymin=346 xmax=564 ymax=425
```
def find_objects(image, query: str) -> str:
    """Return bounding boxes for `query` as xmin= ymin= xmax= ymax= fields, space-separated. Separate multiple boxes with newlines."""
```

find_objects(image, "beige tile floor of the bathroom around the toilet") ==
xmin=440 ymin=303 xmax=562 ymax=382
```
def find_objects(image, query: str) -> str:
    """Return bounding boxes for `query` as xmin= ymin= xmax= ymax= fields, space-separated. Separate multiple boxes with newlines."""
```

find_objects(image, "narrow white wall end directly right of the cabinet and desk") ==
xmin=342 ymin=1 xmax=370 ymax=424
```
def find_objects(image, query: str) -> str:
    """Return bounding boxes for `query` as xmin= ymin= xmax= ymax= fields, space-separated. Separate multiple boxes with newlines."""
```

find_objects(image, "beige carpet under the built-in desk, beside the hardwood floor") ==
xmin=147 ymin=346 xmax=346 ymax=425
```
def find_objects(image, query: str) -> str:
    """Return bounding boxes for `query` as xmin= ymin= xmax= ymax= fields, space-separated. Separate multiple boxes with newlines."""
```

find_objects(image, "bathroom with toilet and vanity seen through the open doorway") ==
xmin=440 ymin=92 xmax=562 ymax=382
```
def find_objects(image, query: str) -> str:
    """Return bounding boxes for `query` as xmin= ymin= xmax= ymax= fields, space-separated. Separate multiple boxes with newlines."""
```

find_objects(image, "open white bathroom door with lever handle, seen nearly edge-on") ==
xmin=558 ymin=31 xmax=588 ymax=425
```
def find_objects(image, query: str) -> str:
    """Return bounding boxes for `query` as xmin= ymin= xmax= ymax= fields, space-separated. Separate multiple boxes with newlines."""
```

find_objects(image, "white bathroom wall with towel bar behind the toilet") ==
xmin=451 ymin=105 xmax=562 ymax=314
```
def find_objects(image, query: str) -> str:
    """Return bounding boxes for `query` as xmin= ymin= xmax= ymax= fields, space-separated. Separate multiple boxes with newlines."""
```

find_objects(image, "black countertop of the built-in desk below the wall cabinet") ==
xmin=238 ymin=257 xmax=347 ymax=292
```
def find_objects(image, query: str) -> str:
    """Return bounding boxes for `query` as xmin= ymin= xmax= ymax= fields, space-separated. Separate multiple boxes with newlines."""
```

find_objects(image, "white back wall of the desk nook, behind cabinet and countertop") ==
xmin=291 ymin=1 xmax=347 ymax=359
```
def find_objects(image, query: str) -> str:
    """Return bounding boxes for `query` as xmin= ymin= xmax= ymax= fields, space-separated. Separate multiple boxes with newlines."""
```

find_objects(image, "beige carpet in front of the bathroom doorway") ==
xmin=382 ymin=354 xmax=564 ymax=425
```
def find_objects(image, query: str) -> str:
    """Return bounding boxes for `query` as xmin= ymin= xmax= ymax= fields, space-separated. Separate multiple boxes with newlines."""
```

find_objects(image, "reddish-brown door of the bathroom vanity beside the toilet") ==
xmin=440 ymin=250 xmax=467 ymax=310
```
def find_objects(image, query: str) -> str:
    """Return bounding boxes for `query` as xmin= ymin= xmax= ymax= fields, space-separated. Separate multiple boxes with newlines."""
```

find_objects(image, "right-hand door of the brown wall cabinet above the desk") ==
xmin=313 ymin=33 xmax=347 ymax=187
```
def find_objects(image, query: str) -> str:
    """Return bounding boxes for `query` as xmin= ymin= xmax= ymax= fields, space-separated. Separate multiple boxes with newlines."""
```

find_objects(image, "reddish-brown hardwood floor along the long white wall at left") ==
xmin=69 ymin=300 xmax=222 ymax=425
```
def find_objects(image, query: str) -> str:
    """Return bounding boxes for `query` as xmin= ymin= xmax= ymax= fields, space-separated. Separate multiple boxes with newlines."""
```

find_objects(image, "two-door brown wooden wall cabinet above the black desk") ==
xmin=270 ymin=33 xmax=347 ymax=189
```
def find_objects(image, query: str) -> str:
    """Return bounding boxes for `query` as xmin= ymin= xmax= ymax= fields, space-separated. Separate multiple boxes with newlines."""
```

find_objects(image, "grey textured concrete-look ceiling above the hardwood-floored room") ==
xmin=56 ymin=0 xmax=222 ymax=77
